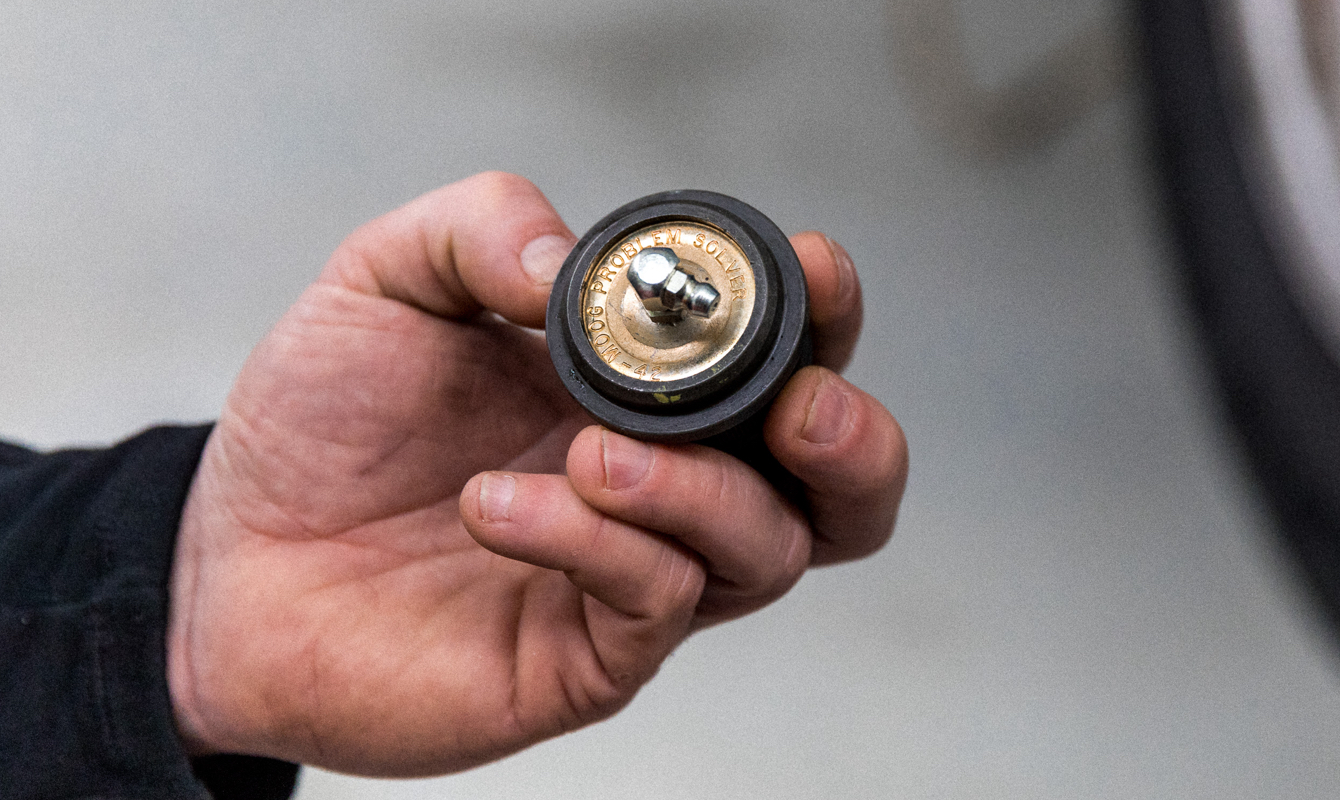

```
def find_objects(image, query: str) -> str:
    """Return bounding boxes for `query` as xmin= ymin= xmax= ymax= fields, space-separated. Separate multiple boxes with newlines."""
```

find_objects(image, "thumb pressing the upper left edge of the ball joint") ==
xmin=319 ymin=173 xmax=576 ymax=327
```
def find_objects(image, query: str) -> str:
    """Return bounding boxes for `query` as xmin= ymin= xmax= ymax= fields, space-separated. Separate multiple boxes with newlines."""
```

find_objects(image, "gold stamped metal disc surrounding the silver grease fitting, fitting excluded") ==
xmin=582 ymin=220 xmax=756 ymax=381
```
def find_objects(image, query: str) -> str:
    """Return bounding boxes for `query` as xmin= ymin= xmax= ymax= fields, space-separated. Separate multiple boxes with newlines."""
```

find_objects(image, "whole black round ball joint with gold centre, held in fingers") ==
xmin=545 ymin=190 xmax=811 ymax=469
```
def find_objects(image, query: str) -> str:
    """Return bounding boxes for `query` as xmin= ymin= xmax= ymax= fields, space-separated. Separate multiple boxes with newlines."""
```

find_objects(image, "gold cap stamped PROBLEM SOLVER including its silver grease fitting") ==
xmin=582 ymin=220 xmax=757 ymax=382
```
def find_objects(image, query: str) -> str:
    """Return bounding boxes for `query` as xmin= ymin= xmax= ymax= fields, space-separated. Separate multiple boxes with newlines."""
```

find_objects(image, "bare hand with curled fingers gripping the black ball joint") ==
xmin=168 ymin=174 xmax=907 ymax=776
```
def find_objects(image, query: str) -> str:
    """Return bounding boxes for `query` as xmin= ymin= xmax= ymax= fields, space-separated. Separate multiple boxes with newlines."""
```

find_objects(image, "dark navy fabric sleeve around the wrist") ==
xmin=0 ymin=426 xmax=297 ymax=800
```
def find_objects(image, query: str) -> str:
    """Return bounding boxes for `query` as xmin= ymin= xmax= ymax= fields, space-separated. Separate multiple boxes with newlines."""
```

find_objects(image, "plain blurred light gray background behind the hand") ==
xmin=0 ymin=0 xmax=1340 ymax=800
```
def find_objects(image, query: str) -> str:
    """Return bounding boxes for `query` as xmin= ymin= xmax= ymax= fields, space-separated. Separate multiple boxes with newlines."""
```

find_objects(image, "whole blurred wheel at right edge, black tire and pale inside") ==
xmin=1139 ymin=0 xmax=1340 ymax=631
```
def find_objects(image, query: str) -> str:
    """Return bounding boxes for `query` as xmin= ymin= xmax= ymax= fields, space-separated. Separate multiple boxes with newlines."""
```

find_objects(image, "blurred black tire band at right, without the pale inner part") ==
xmin=1138 ymin=0 xmax=1340 ymax=635
